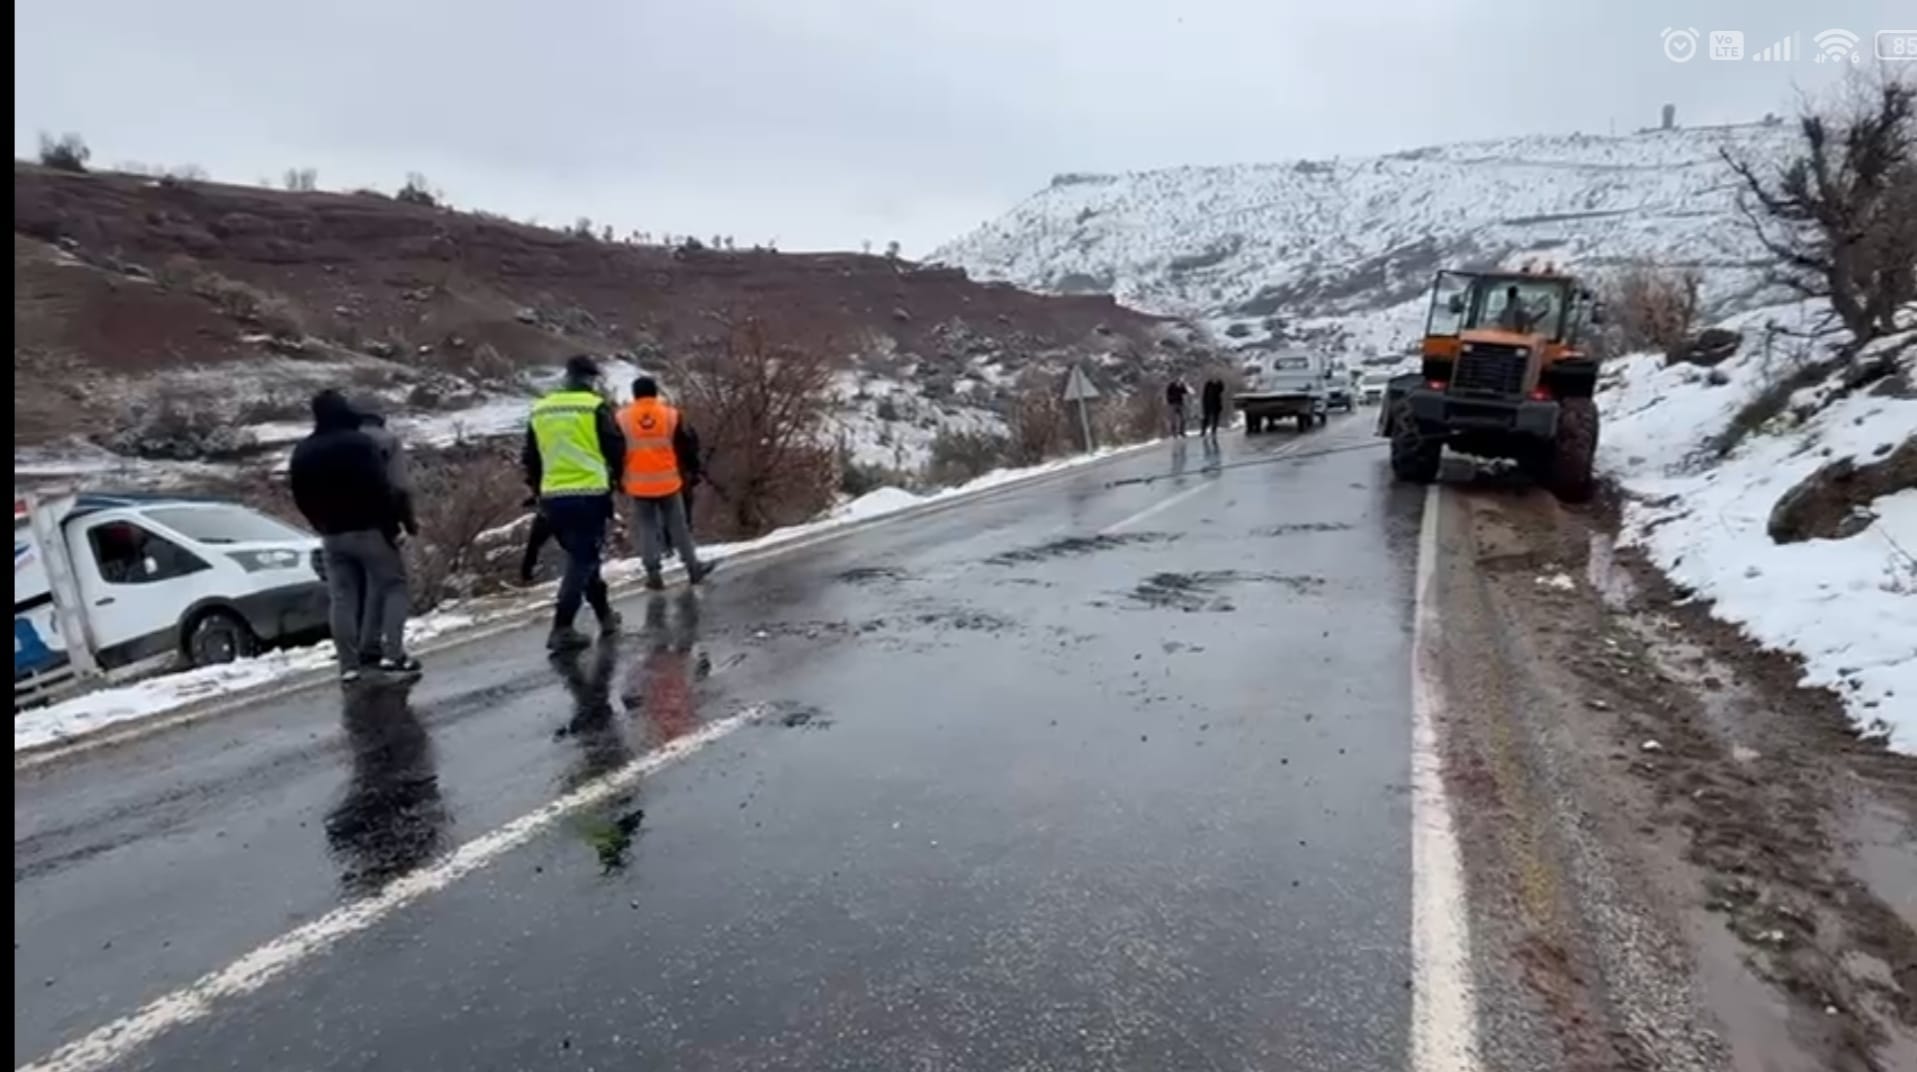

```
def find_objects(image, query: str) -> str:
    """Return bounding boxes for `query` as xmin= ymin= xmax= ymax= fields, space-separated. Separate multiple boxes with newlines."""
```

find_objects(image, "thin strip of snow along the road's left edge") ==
xmin=13 ymin=447 xmax=1129 ymax=752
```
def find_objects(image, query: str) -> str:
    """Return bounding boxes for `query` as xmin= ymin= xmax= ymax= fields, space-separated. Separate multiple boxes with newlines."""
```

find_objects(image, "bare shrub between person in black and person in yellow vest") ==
xmin=404 ymin=445 xmax=527 ymax=612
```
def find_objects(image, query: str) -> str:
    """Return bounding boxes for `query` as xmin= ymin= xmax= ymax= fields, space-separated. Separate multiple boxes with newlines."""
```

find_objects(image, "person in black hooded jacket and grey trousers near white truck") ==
xmin=288 ymin=391 xmax=420 ymax=683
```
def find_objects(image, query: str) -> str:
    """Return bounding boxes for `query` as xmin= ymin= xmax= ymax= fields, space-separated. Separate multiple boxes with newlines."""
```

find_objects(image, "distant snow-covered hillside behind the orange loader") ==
xmin=934 ymin=125 xmax=1790 ymax=351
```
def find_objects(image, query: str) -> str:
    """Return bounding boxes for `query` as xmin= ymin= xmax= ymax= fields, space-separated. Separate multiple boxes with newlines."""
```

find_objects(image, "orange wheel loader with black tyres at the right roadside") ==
xmin=1378 ymin=268 xmax=1599 ymax=502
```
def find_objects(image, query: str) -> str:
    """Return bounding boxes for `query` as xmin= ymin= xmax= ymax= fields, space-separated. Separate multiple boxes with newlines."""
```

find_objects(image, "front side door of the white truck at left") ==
xmin=69 ymin=516 xmax=217 ymax=667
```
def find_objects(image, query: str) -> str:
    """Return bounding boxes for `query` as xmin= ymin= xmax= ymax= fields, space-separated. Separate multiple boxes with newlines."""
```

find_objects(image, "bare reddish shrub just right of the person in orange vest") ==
xmin=677 ymin=318 xmax=840 ymax=539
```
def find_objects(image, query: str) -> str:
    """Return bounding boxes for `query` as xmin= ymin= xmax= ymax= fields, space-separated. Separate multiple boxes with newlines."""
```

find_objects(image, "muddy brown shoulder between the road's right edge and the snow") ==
xmin=1445 ymin=491 xmax=1917 ymax=1072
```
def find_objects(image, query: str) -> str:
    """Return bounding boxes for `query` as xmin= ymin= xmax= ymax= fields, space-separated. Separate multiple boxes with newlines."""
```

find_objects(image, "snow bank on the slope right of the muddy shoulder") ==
xmin=1599 ymin=327 xmax=1917 ymax=752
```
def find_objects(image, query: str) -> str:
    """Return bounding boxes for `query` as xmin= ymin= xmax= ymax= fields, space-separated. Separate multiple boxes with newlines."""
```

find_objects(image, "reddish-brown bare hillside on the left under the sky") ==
xmin=13 ymin=163 xmax=1194 ymax=460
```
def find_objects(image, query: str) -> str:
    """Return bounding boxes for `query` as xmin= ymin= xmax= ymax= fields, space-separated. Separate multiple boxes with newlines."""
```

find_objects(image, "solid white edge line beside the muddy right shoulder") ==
xmin=1411 ymin=485 xmax=1480 ymax=1072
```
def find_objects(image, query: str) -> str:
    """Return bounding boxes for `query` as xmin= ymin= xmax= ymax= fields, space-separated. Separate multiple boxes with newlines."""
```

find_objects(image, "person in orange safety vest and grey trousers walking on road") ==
xmin=619 ymin=376 xmax=711 ymax=591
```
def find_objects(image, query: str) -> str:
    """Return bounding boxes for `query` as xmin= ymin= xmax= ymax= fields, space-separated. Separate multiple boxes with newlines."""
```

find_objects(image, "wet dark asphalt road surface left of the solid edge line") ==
xmin=13 ymin=412 xmax=1420 ymax=1072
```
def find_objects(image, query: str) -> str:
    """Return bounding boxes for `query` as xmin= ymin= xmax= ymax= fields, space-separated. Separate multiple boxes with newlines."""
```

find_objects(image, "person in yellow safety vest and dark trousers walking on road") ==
xmin=520 ymin=355 xmax=627 ymax=652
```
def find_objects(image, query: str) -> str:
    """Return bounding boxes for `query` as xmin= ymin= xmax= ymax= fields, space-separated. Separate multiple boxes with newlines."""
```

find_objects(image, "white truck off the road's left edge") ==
xmin=13 ymin=495 xmax=328 ymax=708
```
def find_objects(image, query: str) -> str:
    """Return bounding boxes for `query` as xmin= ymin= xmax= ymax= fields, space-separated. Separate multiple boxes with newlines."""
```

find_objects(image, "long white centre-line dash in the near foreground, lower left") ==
xmin=19 ymin=708 xmax=765 ymax=1072
